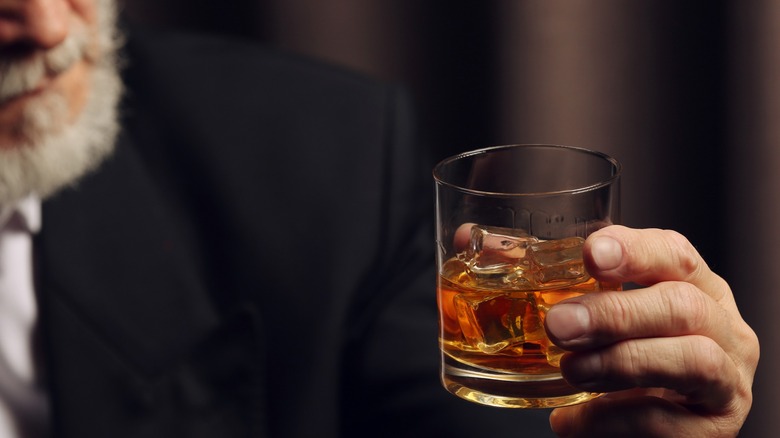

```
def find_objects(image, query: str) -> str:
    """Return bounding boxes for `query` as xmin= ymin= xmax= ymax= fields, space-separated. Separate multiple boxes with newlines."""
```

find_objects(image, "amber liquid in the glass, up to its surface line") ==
xmin=437 ymin=259 xmax=620 ymax=408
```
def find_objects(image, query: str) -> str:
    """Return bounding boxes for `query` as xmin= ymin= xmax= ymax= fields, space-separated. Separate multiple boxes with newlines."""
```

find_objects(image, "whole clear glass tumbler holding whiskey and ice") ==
xmin=433 ymin=145 xmax=621 ymax=408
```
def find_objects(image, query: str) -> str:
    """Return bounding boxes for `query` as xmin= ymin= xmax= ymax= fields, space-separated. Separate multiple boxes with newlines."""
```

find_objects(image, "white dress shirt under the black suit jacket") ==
xmin=0 ymin=197 xmax=49 ymax=438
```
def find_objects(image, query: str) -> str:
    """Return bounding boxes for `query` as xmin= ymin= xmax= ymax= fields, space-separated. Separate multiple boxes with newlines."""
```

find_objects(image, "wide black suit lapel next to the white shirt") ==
xmin=36 ymin=134 xmax=257 ymax=437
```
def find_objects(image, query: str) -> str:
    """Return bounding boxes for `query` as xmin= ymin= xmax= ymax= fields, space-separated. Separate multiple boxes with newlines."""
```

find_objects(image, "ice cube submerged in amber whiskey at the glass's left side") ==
xmin=454 ymin=293 xmax=544 ymax=354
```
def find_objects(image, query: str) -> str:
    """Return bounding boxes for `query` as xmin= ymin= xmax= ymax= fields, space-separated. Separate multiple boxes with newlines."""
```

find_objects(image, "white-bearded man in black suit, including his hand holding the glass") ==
xmin=0 ymin=0 xmax=758 ymax=438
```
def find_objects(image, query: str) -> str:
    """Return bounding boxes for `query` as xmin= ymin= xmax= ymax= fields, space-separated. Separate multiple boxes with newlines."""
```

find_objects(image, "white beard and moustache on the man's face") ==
xmin=0 ymin=0 xmax=122 ymax=205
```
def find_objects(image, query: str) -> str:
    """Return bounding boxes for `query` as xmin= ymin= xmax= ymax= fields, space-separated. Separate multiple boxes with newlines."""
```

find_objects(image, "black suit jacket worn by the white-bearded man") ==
xmin=36 ymin=29 xmax=546 ymax=438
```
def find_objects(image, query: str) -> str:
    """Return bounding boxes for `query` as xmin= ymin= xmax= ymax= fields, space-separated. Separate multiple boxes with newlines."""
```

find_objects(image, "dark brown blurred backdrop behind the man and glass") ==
xmin=116 ymin=0 xmax=780 ymax=437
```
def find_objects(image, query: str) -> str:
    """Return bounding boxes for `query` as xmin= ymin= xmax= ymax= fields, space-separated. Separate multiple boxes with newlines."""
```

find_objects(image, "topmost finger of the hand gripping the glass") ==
xmin=583 ymin=225 xmax=733 ymax=301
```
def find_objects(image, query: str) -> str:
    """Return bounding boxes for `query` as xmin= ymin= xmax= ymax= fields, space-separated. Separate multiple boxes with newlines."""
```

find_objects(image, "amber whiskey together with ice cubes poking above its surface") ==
xmin=437 ymin=234 xmax=621 ymax=407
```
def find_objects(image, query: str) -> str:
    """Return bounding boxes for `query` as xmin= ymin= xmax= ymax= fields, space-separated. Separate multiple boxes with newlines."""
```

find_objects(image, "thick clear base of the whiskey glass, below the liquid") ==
xmin=442 ymin=364 xmax=602 ymax=409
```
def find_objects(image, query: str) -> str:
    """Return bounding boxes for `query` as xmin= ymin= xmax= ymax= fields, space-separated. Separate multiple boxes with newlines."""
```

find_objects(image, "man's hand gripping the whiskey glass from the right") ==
xmin=546 ymin=226 xmax=759 ymax=438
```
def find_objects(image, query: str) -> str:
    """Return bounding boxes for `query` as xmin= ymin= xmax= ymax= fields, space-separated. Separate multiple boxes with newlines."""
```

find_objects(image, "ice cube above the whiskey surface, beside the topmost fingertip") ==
xmin=527 ymin=237 xmax=590 ymax=287
